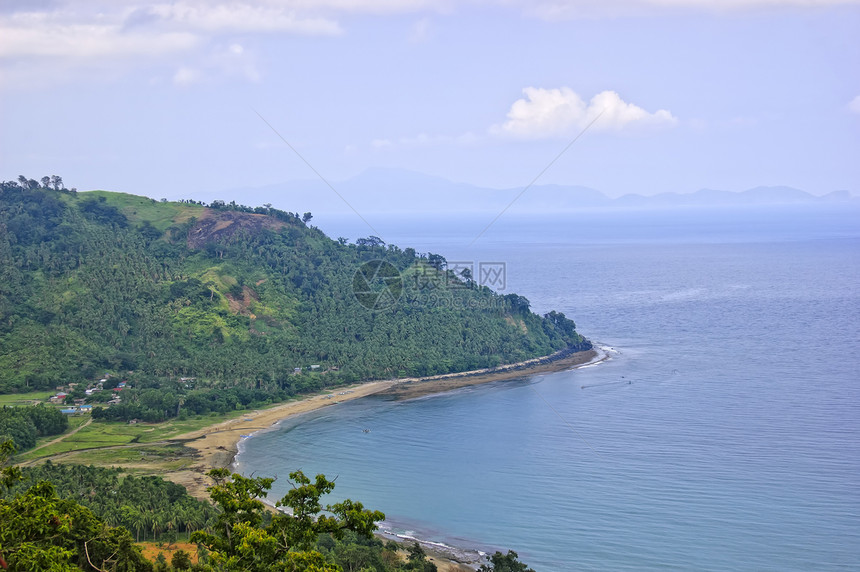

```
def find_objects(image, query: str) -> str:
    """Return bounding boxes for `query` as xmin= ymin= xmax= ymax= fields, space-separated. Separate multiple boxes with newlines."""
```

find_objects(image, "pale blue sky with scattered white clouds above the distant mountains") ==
xmin=0 ymin=0 xmax=860 ymax=202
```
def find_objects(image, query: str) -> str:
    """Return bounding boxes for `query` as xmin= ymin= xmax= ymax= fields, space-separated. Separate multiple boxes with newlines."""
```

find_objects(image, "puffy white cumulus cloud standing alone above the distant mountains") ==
xmin=498 ymin=87 xmax=678 ymax=139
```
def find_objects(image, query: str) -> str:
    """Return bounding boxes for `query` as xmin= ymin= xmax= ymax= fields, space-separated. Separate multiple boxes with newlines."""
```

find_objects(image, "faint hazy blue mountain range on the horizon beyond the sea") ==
xmin=190 ymin=168 xmax=860 ymax=218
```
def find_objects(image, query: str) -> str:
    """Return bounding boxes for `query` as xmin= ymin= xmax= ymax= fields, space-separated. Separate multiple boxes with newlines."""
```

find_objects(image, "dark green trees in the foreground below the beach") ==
xmin=0 ymin=441 xmax=531 ymax=572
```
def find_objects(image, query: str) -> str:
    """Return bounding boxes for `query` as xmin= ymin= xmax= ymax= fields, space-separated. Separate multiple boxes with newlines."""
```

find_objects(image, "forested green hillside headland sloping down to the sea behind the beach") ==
xmin=0 ymin=177 xmax=589 ymax=394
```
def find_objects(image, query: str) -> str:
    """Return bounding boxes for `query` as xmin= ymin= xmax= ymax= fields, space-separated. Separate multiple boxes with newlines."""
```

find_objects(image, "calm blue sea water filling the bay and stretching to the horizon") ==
xmin=238 ymin=207 xmax=860 ymax=571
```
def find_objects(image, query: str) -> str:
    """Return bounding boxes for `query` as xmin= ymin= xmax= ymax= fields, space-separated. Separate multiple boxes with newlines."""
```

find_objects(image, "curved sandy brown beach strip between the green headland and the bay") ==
xmin=164 ymin=349 xmax=609 ymax=499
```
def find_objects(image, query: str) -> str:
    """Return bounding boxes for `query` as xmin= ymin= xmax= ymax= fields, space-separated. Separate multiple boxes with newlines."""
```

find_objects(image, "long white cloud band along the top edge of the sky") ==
xmin=5 ymin=0 xmax=860 ymax=58
